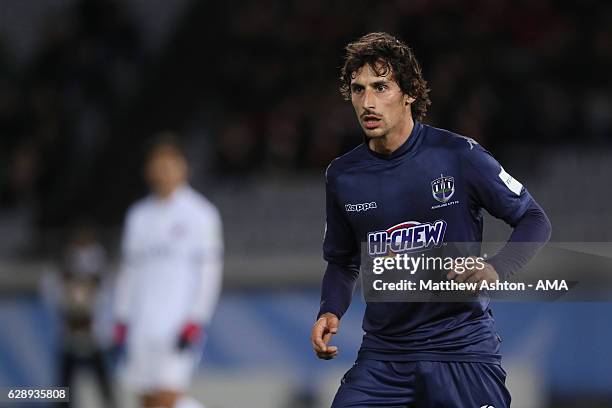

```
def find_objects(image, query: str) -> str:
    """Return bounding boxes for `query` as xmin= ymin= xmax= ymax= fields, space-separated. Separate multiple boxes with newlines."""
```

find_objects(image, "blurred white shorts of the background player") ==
xmin=120 ymin=342 xmax=202 ymax=394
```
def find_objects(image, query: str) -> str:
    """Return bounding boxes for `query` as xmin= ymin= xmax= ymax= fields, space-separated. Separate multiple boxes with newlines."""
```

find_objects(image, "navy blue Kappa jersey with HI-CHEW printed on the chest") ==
xmin=321 ymin=122 xmax=533 ymax=362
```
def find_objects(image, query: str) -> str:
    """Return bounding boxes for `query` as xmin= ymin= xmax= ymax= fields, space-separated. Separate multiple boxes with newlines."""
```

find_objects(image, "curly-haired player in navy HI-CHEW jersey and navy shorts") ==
xmin=311 ymin=33 xmax=550 ymax=408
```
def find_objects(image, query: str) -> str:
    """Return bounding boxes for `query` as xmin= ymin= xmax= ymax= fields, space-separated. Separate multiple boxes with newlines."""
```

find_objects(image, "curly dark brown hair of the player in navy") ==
xmin=340 ymin=33 xmax=431 ymax=120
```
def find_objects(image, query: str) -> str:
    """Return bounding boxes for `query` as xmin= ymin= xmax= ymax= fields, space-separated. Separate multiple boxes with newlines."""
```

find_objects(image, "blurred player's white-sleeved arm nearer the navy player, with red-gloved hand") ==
xmin=178 ymin=211 xmax=223 ymax=349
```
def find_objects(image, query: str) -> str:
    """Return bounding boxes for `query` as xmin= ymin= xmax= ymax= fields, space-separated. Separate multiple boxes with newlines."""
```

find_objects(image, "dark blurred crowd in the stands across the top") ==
xmin=0 ymin=0 xmax=612 ymax=255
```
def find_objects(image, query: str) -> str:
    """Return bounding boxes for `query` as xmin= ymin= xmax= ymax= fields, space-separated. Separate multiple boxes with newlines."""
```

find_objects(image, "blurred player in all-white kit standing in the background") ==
xmin=115 ymin=134 xmax=223 ymax=408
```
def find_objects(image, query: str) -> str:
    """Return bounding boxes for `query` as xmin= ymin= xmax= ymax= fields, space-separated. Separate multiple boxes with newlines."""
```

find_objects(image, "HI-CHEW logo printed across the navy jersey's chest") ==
xmin=368 ymin=220 xmax=446 ymax=256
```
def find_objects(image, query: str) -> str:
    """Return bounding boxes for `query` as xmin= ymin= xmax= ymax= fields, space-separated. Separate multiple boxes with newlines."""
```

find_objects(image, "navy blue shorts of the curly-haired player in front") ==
xmin=332 ymin=358 xmax=510 ymax=408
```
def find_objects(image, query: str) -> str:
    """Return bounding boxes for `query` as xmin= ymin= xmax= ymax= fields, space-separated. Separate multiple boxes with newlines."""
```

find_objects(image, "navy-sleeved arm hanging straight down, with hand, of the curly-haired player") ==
xmin=311 ymin=166 xmax=360 ymax=360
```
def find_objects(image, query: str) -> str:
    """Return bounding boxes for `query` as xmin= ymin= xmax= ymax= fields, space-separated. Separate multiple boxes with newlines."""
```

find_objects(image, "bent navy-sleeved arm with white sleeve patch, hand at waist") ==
xmin=449 ymin=145 xmax=551 ymax=282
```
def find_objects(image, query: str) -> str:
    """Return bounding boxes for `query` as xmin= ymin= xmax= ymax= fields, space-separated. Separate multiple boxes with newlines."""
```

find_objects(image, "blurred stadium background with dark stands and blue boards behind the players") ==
xmin=0 ymin=0 xmax=612 ymax=408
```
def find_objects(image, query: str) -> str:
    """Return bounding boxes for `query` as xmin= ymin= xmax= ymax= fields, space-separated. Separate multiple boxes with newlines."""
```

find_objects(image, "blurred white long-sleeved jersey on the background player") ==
xmin=116 ymin=186 xmax=223 ymax=346
